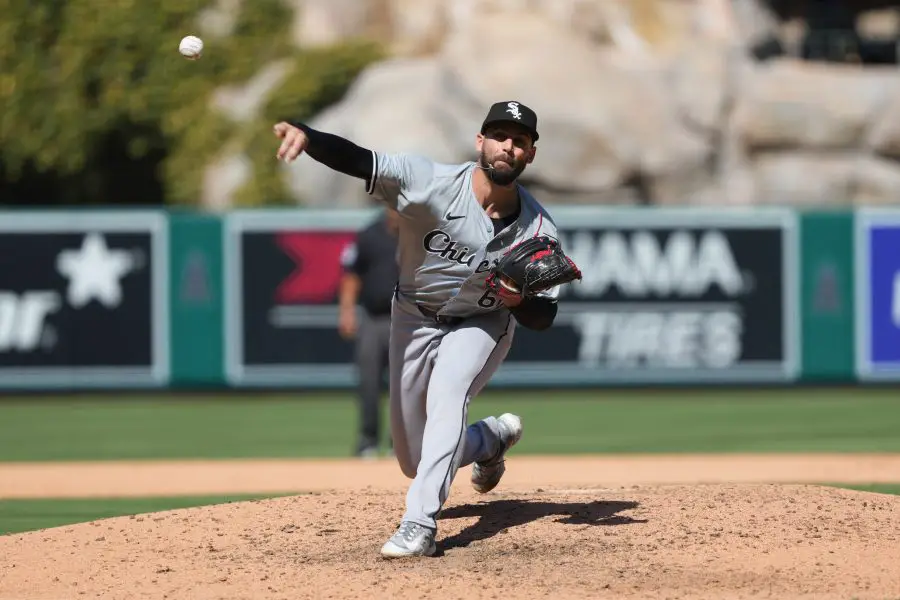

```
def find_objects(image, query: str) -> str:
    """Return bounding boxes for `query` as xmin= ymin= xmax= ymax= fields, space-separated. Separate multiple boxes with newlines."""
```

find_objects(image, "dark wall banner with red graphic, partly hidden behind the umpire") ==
xmin=225 ymin=210 xmax=377 ymax=387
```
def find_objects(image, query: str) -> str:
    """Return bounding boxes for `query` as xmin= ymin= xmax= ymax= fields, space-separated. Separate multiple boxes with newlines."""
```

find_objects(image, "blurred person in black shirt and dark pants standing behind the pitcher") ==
xmin=338 ymin=209 xmax=400 ymax=458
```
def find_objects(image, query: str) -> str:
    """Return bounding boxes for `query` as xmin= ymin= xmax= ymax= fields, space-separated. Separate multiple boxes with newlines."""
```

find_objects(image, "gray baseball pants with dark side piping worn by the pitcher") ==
xmin=390 ymin=294 xmax=515 ymax=529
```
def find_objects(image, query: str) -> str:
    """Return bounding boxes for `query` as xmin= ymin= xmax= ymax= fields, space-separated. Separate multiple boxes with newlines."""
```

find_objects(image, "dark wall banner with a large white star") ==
xmin=0 ymin=211 xmax=169 ymax=388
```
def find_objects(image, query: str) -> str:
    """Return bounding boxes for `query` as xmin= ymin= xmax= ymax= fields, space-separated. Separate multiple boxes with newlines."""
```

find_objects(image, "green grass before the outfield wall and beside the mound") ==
xmin=0 ymin=388 xmax=900 ymax=534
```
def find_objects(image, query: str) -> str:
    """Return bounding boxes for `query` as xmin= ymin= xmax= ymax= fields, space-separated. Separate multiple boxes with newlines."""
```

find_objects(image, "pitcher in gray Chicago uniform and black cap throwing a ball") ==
xmin=274 ymin=102 xmax=581 ymax=557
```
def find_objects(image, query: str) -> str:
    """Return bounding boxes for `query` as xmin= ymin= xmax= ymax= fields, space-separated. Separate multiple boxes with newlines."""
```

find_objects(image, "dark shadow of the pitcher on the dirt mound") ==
xmin=438 ymin=500 xmax=647 ymax=553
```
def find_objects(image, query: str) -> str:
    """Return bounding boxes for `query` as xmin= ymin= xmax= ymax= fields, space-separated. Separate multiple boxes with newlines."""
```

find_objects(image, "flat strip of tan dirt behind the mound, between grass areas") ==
xmin=0 ymin=454 xmax=900 ymax=498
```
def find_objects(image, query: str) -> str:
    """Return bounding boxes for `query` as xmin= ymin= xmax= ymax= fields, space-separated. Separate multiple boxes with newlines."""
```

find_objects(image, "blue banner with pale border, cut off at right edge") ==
xmin=856 ymin=209 xmax=900 ymax=381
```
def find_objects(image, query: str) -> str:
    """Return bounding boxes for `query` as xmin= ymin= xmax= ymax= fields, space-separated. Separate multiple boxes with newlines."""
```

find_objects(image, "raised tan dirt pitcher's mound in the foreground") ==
xmin=0 ymin=484 xmax=900 ymax=600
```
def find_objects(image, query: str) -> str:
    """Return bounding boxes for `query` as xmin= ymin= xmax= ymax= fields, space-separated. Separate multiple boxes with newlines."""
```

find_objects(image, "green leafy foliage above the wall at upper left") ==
xmin=0 ymin=0 xmax=380 ymax=204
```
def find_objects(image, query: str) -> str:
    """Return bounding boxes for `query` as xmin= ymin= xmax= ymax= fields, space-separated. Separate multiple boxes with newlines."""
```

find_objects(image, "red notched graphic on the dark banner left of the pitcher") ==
xmin=275 ymin=231 xmax=356 ymax=304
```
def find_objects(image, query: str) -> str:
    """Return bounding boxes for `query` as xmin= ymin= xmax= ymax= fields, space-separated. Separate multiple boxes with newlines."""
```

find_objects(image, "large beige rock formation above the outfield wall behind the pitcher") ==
xmin=207 ymin=0 xmax=900 ymax=207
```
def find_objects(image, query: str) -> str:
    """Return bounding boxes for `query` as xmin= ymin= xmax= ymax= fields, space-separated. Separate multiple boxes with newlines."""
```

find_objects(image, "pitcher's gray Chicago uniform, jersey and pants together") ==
xmin=367 ymin=152 xmax=559 ymax=529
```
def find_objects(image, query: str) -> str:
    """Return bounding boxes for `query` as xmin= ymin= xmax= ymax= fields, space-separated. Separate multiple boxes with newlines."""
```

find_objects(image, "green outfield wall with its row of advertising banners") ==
xmin=0 ymin=206 xmax=900 ymax=390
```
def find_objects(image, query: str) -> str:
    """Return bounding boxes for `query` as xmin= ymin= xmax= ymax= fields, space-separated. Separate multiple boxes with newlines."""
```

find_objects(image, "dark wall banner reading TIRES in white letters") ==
xmin=495 ymin=208 xmax=799 ymax=385
